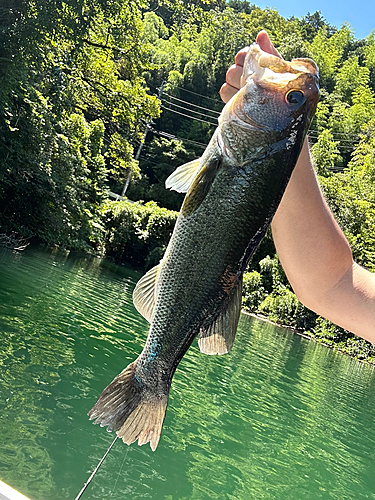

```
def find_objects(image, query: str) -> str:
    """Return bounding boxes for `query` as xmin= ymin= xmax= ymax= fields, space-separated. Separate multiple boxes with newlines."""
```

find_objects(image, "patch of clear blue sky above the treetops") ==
xmin=254 ymin=0 xmax=375 ymax=38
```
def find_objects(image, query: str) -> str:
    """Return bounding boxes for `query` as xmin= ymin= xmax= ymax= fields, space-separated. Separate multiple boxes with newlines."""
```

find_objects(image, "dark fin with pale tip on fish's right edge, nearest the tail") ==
xmin=198 ymin=279 xmax=242 ymax=354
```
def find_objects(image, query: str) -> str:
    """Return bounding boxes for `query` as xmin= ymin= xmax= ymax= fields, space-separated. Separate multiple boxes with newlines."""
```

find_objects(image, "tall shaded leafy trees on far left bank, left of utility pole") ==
xmin=0 ymin=0 xmax=159 ymax=251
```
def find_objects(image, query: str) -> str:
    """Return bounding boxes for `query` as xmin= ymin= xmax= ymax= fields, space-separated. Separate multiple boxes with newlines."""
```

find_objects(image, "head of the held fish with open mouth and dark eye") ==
xmin=219 ymin=43 xmax=319 ymax=139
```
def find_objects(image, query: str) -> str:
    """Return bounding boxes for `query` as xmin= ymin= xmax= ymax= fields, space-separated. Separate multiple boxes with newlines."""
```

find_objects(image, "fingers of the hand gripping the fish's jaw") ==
xmin=220 ymin=31 xmax=281 ymax=103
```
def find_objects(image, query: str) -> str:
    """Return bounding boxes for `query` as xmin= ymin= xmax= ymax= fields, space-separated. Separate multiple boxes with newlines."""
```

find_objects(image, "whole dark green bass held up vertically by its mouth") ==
xmin=88 ymin=43 xmax=319 ymax=451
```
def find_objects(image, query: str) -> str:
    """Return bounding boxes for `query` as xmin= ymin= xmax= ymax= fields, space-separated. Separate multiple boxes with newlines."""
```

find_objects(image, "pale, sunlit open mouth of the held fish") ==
xmin=241 ymin=43 xmax=319 ymax=87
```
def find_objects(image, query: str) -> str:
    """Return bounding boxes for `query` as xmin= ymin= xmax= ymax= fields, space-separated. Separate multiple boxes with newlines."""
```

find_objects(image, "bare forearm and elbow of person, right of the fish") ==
xmin=272 ymin=142 xmax=375 ymax=343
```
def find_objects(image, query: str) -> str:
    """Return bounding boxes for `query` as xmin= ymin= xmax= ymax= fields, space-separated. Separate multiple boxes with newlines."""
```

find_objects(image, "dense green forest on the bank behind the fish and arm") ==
xmin=0 ymin=0 xmax=375 ymax=362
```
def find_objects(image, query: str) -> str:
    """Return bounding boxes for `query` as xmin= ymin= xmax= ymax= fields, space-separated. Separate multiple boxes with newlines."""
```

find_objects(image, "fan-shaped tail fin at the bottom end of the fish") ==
xmin=88 ymin=360 xmax=168 ymax=451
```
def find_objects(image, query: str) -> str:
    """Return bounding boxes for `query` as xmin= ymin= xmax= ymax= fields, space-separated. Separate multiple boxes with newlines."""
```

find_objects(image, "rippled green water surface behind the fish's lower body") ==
xmin=0 ymin=248 xmax=375 ymax=500
